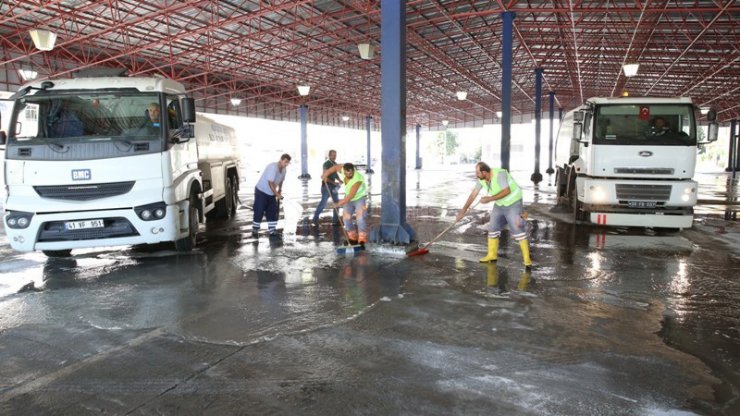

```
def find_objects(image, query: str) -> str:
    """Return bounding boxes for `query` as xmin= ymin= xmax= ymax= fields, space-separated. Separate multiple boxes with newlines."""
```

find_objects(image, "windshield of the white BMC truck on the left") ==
xmin=9 ymin=92 xmax=164 ymax=144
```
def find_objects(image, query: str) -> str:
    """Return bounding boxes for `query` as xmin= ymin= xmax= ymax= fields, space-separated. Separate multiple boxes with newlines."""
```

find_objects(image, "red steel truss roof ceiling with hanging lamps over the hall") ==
xmin=0 ymin=0 xmax=740 ymax=128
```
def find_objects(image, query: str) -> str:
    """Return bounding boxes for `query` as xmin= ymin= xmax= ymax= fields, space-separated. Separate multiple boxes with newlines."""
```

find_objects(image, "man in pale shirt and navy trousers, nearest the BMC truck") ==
xmin=252 ymin=153 xmax=290 ymax=237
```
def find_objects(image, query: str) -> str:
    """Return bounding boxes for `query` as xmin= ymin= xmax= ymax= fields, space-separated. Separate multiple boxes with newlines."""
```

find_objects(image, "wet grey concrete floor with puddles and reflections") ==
xmin=0 ymin=169 xmax=740 ymax=415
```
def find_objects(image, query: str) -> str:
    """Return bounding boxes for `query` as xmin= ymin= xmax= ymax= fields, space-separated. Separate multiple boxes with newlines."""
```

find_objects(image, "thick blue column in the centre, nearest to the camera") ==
xmin=371 ymin=0 xmax=416 ymax=244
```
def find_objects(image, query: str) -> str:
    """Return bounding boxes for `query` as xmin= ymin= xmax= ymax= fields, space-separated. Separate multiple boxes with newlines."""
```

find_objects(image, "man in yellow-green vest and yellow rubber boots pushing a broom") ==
xmin=456 ymin=162 xmax=532 ymax=268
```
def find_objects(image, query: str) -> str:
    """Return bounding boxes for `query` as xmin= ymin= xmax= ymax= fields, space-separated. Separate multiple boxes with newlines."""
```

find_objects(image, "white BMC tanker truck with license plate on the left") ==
xmin=3 ymin=77 xmax=239 ymax=257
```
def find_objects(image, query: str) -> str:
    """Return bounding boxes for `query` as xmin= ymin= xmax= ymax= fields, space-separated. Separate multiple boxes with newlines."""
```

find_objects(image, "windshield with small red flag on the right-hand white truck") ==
xmin=593 ymin=104 xmax=696 ymax=146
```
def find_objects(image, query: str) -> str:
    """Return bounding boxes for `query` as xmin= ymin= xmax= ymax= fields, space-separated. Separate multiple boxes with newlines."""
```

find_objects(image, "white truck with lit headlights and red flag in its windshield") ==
xmin=555 ymin=97 xmax=717 ymax=229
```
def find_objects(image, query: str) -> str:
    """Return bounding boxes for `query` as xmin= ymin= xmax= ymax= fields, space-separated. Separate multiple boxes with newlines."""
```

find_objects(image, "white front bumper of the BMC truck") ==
xmin=4 ymin=205 xmax=180 ymax=251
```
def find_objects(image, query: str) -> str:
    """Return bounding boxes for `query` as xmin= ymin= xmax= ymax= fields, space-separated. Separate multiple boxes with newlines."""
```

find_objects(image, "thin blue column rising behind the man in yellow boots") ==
xmin=501 ymin=12 xmax=516 ymax=170
